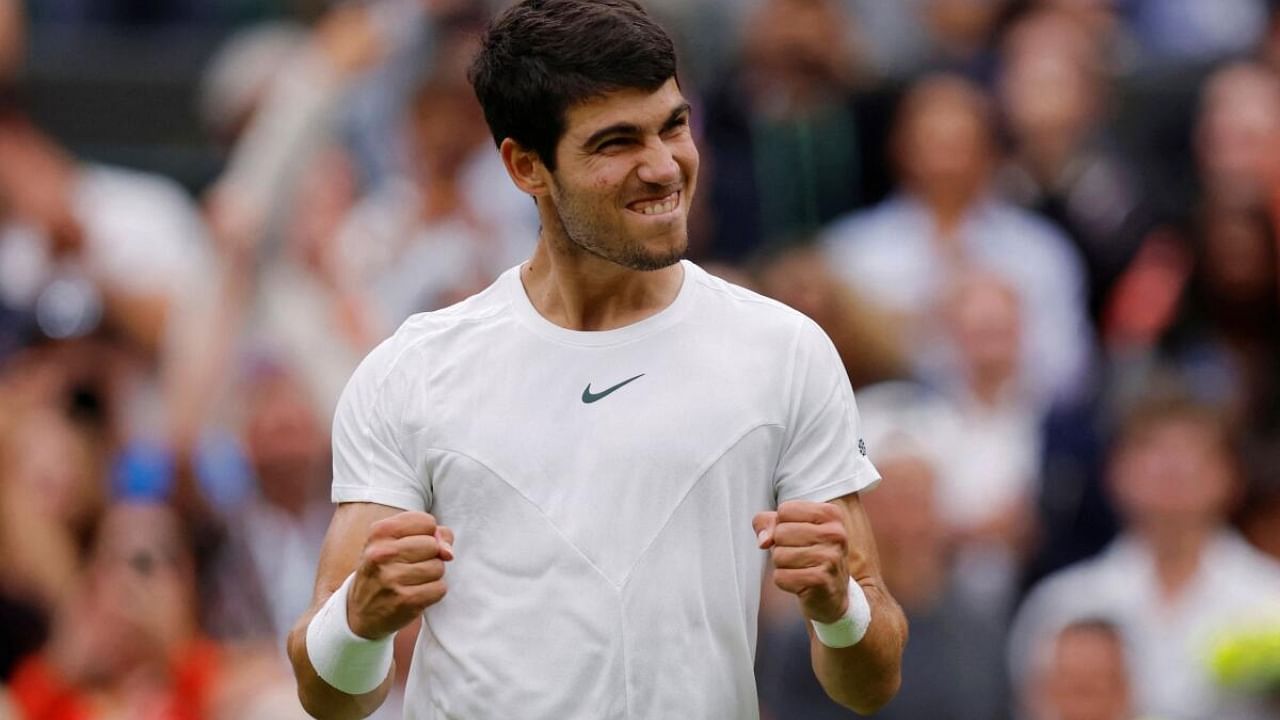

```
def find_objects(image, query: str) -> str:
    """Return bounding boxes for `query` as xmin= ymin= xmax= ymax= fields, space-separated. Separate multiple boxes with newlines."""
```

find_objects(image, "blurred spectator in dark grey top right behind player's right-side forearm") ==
xmin=756 ymin=404 xmax=1007 ymax=720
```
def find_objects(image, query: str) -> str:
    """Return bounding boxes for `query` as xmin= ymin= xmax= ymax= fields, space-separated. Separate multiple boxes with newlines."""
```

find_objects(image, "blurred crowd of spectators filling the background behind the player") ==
xmin=0 ymin=0 xmax=1280 ymax=720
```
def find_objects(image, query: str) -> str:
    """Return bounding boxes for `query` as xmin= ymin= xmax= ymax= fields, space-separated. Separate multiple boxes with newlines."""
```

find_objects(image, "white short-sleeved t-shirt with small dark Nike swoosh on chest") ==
xmin=333 ymin=263 xmax=878 ymax=720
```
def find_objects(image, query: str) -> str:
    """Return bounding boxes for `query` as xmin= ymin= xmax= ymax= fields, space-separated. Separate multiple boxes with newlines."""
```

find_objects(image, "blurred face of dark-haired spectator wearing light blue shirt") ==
xmin=895 ymin=77 xmax=993 ymax=199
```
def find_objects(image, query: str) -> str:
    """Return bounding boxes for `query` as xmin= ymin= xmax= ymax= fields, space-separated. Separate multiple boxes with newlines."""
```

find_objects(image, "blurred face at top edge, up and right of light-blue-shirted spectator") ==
xmin=998 ymin=13 xmax=1100 ymax=141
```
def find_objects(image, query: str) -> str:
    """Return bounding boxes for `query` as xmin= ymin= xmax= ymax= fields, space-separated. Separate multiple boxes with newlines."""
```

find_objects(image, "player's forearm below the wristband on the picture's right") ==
xmin=805 ymin=579 xmax=908 ymax=715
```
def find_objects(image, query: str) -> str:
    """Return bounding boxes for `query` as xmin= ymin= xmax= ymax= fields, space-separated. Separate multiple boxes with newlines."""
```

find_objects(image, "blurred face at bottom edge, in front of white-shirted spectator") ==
xmin=1037 ymin=625 xmax=1130 ymax=720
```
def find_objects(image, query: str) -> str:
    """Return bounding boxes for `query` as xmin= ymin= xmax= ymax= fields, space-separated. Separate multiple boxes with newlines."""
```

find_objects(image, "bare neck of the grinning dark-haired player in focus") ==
xmin=520 ymin=229 xmax=685 ymax=331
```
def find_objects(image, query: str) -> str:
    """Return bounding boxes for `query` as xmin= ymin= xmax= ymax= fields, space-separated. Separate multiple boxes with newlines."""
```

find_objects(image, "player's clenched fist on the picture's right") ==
xmin=751 ymin=500 xmax=849 ymax=623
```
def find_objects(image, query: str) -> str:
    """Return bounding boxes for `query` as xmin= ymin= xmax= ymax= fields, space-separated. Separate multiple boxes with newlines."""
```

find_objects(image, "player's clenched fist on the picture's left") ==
xmin=347 ymin=512 xmax=453 ymax=639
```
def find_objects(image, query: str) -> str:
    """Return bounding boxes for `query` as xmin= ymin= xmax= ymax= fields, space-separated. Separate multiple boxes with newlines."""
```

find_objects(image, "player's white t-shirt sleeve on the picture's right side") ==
xmin=773 ymin=319 xmax=879 ymax=503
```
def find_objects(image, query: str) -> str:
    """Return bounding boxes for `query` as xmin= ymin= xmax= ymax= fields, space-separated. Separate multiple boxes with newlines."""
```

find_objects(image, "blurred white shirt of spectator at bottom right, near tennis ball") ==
xmin=1010 ymin=532 xmax=1280 ymax=720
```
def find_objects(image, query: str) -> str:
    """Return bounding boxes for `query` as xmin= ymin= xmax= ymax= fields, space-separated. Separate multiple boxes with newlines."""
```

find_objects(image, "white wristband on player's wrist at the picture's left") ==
xmin=307 ymin=573 xmax=396 ymax=694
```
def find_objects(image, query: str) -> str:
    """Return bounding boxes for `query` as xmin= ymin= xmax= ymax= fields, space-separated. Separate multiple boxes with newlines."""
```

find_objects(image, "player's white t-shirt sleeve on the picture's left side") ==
xmin=332 ymin=337 xmax=431 ymax=511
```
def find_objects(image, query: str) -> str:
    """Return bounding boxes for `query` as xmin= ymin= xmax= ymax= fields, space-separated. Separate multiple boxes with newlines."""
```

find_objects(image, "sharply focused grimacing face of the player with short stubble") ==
xmin=543 ymin=78 xmax=699 ymax=270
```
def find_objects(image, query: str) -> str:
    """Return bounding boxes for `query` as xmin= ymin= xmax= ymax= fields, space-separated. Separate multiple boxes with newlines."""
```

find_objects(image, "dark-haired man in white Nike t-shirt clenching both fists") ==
xmin=289 ymin=0 xmax=906 ymax=720
